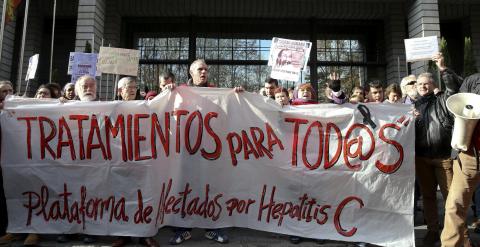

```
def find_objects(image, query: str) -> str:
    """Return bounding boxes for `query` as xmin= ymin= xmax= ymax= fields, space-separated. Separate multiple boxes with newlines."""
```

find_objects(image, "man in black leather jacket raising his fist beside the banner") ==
xmin=415 ymin=53 xmax=461 ymax=246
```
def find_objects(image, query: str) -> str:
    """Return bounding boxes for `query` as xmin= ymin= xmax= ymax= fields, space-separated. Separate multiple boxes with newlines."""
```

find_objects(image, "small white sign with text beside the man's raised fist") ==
xmin=404 ymin=36 xmax=438 ymax=62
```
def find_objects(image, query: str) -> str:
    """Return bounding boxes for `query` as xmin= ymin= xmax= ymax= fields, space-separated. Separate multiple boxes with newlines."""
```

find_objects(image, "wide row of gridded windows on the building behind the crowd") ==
xmin=136 ymin=34 xmax=366 ymax=97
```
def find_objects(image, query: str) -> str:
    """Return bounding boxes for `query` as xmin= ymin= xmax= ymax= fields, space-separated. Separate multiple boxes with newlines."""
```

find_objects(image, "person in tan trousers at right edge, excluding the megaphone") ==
xmin=441 ymin=73 xmax=480 ymax=247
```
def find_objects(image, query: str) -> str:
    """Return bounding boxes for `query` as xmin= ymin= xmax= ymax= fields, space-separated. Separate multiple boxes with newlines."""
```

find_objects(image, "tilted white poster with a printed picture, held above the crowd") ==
xmin=268 ymin=38 xmax=312 ymax=82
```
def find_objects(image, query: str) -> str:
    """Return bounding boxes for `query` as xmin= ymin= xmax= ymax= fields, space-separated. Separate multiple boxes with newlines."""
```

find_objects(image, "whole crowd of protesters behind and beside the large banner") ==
xmin=0 ymin=53 xmax=480 ymax=247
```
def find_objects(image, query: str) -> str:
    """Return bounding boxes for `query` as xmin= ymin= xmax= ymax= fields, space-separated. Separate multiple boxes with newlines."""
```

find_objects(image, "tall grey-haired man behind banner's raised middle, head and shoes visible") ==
xmin=169 ymin=59 xmax=243 ymax=245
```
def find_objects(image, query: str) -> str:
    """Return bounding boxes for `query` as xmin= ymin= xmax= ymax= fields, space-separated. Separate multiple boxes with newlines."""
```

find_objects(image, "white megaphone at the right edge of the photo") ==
xmin=447 ymin=93 xmax=480 ymax=151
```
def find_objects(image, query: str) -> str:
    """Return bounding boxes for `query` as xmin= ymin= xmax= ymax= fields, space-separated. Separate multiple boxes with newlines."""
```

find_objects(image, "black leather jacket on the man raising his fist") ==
xmin=415 ymin=69 xmax=462 ymax=158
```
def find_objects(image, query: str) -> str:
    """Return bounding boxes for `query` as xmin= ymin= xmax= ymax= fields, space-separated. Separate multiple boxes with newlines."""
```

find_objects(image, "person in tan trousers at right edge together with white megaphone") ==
xmin=441 ymin=73 xmax=480 ymax=247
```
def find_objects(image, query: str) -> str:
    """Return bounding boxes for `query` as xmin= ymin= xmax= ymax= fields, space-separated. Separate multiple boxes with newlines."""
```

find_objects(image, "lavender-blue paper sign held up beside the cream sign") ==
xmin=68 ymin=52 xmax=98 ymax=82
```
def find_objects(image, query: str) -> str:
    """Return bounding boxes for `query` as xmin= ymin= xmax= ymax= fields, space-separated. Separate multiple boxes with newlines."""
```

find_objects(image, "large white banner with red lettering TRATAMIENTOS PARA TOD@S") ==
xmin=0 ymin=87 xmax=415 ymax=247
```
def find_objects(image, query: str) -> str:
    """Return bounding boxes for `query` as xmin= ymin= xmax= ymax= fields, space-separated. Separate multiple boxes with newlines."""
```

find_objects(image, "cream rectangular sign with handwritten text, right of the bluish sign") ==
xmin=97 ymin=46 xmax=140 ymax=76
